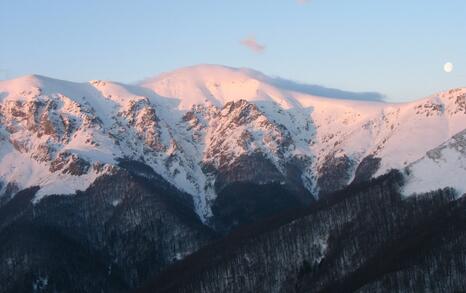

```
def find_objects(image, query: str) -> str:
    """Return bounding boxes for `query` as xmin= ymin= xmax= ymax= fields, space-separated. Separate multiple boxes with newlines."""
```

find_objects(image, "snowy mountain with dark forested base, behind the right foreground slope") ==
xmin=0 ymin=65 xmax=466 ymax=292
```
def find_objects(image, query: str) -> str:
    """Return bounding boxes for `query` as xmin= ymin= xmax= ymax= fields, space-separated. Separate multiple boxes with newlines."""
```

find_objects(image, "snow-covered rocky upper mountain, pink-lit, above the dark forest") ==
xmin=0 ymin=65 xmax=466 ymax=219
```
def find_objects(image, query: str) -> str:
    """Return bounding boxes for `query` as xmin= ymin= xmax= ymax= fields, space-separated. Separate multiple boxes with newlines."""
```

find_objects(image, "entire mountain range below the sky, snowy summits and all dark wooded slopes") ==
xmin=0 ymin=63 xmax=466 ymax=292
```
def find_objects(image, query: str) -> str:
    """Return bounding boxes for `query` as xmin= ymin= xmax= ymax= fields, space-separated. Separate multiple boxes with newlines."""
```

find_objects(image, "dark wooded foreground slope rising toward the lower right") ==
xmin=143 ymin=171 xmax=466 ymax=292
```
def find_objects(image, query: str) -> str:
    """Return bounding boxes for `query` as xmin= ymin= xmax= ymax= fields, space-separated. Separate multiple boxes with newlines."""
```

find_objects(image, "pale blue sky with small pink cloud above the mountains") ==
xmin=0 ymin=0 xmax=466 ymax=101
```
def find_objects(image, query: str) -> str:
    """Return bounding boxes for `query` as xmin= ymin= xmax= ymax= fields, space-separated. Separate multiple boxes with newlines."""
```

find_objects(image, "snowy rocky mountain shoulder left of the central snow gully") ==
xmin=0 ymin=76 xmax=213 ymax=218
